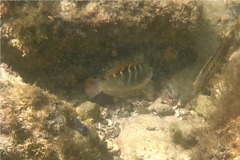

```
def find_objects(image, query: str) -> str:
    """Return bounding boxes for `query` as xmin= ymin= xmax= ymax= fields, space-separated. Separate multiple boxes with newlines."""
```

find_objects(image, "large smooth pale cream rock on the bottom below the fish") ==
xmin=118 ymin=115 xmax=190 ymax=160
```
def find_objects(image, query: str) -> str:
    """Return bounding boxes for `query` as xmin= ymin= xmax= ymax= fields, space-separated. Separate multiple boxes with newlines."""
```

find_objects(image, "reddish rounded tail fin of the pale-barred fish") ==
xmin=84 ymin=78 xmax=102 ymax=98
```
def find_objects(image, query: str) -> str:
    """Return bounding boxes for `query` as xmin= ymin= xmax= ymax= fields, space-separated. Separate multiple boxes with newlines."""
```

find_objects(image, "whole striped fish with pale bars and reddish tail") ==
xmin=85 ymin=62 xmax=153 ymax=98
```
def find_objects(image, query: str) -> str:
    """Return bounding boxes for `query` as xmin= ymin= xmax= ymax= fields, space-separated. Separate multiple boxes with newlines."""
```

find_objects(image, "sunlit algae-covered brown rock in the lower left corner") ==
xmin=0 ymin=63 xmax=101 ymax=160
